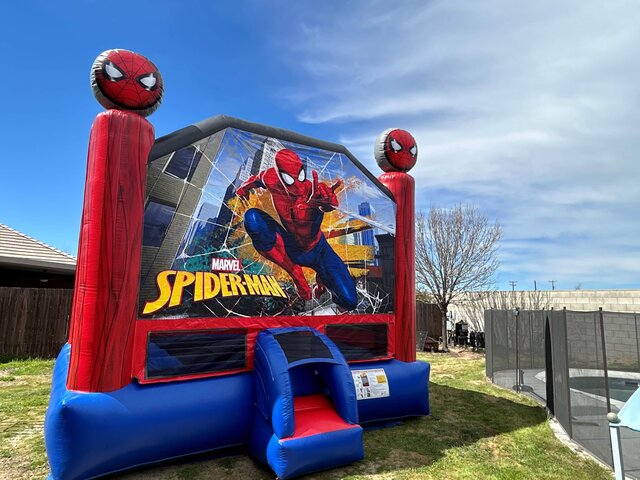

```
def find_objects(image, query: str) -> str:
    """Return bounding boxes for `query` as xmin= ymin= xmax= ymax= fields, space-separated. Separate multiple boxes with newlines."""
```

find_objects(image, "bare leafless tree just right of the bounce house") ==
xmin=416 ymin=205 xmax=502 ymax=351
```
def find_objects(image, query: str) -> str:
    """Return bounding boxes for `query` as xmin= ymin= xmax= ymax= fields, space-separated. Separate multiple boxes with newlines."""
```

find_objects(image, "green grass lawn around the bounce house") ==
xmin=0 ymin=353 xmax=612 ymax=480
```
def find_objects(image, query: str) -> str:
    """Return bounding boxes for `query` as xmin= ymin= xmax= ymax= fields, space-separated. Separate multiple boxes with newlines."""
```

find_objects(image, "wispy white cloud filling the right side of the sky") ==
xmin=280 ymin=0 xmax=640 ymax=288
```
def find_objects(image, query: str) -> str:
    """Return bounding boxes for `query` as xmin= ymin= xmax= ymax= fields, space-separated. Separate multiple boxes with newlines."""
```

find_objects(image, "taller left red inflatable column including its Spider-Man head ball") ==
xmin=67 ymin=50 xmax=162 ymax=392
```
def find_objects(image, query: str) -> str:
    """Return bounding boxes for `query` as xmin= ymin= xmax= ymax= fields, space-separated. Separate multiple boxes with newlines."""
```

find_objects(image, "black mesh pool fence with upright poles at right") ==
xmin=484 ymin=309 xmax=640 ymax=479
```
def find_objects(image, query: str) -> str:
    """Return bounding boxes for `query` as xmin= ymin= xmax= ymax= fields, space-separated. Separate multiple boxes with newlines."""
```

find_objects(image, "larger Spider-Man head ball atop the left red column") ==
xmin=91 ymin=49 xmax=164 ymax=117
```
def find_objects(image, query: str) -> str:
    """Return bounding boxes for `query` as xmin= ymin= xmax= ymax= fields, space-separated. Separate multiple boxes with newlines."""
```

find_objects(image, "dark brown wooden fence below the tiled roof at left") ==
xmin=0 ymin=287 xmax=73 ymax=358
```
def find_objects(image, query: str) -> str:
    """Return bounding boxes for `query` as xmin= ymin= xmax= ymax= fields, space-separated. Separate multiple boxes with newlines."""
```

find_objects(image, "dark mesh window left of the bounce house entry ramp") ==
xmin=147 ymin=329 xmax=246 ymax=378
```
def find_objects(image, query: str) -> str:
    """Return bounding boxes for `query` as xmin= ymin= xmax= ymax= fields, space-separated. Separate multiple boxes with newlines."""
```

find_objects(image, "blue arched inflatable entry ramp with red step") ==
xmin=250 ymin=327 xmax=364 ymax=479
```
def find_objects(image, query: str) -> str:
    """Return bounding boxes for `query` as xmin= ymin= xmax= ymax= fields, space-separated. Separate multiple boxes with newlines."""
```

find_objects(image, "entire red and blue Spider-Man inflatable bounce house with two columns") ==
xmin=45 ymin=50 xmax=429 ymax=480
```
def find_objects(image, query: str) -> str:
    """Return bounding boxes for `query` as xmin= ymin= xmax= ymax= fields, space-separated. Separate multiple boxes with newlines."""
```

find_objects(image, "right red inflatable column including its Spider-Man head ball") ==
xmin=375 ymin=129 xmax=418 ymax=362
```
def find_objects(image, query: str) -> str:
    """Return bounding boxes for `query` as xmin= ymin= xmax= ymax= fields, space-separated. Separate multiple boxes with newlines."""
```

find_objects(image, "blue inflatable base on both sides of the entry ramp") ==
xmin=45 ymin=345 xmax=429 ymax=480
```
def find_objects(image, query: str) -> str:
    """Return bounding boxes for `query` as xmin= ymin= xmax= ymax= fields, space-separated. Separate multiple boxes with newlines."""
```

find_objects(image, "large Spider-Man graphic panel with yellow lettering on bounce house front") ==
xmin=139 ymin=128 xmax=395 ymax=319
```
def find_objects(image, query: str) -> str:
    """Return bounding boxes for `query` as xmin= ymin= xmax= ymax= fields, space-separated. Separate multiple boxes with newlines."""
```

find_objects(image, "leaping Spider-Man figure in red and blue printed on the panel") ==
xmin=236 ymin=149 xmax=358 ymax=310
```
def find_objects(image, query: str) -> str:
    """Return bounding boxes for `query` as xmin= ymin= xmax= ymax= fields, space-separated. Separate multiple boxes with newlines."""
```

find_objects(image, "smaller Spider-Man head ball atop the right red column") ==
xmin=375 ymin=128 xmax=418 ymax=172
